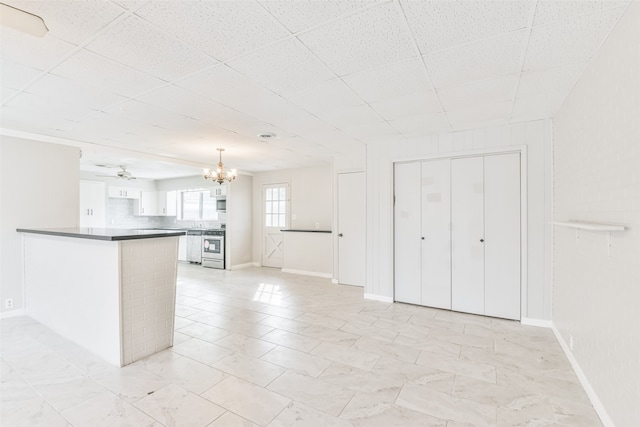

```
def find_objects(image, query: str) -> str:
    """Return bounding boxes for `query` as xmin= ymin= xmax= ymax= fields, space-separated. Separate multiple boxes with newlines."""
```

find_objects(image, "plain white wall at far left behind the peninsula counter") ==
xmin=0 ymin=136 xmax=80 ymax=314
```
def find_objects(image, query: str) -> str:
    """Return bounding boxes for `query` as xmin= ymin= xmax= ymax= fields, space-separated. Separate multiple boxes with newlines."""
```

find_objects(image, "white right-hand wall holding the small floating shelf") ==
xmin=553 ymin=2 xmax=640 ymax=427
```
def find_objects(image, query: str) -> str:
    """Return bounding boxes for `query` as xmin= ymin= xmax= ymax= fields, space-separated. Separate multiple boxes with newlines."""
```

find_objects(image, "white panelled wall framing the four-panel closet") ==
xmin=365 ymin=120 xmax=552 ymax=321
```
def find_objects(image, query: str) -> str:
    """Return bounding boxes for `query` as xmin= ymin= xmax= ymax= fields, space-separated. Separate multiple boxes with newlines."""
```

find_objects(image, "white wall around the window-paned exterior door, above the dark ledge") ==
xmin=253 ymin=165 xmax=333 ymax=263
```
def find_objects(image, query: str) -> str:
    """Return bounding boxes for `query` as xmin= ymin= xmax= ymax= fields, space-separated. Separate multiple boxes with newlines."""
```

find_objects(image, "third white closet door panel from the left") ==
xmin=451 ymin=157 xmax=484 ymax=314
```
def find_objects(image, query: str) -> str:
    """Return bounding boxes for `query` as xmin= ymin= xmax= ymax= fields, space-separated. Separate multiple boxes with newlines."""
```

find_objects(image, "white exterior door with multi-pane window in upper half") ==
xmin=262 ymin=183 xmax=289 ymax=268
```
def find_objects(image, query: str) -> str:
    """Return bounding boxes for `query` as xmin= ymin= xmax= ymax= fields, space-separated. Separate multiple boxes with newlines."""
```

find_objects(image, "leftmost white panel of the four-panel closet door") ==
xmin=394 ymin=162 xmax=422 ymax=304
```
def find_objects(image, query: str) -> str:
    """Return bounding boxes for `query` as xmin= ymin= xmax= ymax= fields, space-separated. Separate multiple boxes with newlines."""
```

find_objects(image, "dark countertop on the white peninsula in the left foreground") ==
xmin=16 ymin=227 xmax=185 ymax=241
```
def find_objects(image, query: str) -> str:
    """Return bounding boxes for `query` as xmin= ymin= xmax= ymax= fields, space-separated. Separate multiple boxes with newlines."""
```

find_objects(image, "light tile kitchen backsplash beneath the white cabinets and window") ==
xmin=106 ymin=198 xmax=226 ymax=228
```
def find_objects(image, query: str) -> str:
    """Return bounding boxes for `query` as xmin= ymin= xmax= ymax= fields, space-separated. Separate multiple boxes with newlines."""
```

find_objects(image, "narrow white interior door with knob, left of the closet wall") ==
xmin=338 ymin=172 xmax=367 ymax=286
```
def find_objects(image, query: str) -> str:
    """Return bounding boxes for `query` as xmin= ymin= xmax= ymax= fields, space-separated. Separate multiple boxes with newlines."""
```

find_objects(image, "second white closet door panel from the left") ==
xmin=421 ymin=159 xmax=451 ymax=310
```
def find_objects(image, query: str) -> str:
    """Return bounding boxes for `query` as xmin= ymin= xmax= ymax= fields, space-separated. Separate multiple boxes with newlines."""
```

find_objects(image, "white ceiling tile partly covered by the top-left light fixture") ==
xmin=4 ymin=0 xmax=124 ymax=45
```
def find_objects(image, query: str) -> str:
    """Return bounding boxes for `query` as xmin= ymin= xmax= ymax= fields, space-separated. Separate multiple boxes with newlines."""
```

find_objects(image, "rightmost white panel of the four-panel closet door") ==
xmin=484 ymin=154 xmax=520 ymax=320
